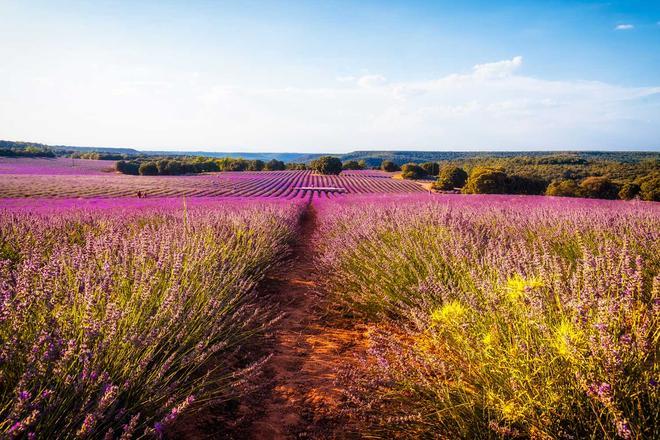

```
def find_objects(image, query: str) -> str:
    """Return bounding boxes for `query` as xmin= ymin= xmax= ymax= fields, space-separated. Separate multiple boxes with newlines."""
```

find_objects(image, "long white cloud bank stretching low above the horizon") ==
xmin=0 ymin=56 xmax=660 ymax=151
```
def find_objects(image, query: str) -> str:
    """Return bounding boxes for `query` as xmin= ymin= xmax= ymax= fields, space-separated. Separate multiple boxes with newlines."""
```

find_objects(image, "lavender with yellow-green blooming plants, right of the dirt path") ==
xmin=318 ymin=196 xmax=660 ymax=439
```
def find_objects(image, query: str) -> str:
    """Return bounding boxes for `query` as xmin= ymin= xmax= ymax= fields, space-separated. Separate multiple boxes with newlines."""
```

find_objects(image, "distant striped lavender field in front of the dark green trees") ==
xmin=0 ymin=159 xmax=423 ymax=199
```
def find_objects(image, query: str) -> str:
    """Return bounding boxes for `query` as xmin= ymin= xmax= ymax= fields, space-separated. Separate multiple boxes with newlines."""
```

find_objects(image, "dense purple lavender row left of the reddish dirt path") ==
xmin=0 ymin=199 xmax=303 ymax=439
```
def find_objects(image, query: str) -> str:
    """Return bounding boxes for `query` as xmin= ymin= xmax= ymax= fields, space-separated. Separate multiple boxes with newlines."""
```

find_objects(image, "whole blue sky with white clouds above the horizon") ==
xmin=0 ymin=0 xmax=660 ymax=153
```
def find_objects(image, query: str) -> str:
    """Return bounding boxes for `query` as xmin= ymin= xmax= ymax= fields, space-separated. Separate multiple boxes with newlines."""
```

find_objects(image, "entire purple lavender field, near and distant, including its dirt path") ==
xmin=0 ymin=159 xmax=660 ymax=439
